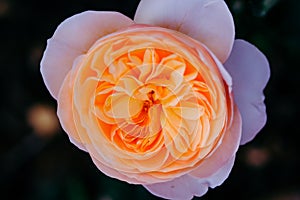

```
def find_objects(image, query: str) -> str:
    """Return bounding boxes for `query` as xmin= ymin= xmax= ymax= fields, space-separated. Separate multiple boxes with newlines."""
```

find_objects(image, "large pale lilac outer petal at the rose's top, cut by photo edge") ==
xmin=134 ymin=0 xmax=235 ymax=63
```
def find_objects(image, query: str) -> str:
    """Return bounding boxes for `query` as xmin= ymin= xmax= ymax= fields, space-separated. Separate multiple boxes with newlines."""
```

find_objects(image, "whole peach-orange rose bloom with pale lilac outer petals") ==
xmin=41 ymin=0 xmax=270 ymax=199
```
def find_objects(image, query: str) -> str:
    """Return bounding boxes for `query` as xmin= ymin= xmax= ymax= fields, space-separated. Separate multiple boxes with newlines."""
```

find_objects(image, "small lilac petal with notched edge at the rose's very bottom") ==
xmin=143 ymin=175 xmax=208 ymax=200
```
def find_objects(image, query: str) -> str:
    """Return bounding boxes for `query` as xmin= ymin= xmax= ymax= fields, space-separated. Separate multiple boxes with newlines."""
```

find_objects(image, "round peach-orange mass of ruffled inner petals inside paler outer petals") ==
xmin=61 ymin=27 xmax=232 ymax=184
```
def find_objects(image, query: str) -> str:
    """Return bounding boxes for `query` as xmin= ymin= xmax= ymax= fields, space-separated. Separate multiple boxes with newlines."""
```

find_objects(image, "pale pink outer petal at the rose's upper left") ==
xmin=41 ymin=11 xmax=134 ymax=99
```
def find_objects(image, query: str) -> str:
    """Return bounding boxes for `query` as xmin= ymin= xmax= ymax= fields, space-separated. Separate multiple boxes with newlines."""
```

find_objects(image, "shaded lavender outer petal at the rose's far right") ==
xmin=225 ymin=40 xmax=270 ymax=144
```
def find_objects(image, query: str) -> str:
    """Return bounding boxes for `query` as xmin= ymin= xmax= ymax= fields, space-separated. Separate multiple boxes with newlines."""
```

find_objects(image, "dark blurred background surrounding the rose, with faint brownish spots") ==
xmin=0 ymin=0 xmax=300 ymax=200
